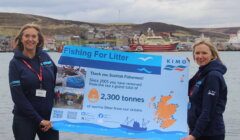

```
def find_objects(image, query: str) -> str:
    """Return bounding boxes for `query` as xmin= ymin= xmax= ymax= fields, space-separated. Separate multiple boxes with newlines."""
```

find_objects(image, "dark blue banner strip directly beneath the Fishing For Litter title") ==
xmin=58 ymin=56 xmax=161 ymax=75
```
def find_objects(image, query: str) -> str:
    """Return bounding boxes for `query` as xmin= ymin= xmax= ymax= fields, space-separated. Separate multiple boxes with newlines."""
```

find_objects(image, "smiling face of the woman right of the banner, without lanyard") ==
xmin=193 ymin=44 xmax=213 ymax=66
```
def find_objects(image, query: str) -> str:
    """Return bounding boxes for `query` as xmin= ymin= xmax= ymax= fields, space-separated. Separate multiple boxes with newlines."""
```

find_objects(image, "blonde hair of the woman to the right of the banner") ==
xmin=192 ymin=38 xmax=221 ymax=61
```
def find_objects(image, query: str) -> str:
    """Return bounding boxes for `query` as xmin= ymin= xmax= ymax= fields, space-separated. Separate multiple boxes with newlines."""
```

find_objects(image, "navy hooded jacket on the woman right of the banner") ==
xmin=188 ymin=60 xmax=227 ymax=138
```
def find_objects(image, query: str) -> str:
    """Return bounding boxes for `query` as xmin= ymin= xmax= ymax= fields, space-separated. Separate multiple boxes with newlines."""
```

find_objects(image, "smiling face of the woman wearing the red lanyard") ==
xmin=21 ymin=28 xmax=39 ymax=51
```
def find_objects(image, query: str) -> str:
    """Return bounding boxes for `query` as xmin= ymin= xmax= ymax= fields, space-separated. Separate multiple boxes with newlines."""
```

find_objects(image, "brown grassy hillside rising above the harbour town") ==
xmin=0 ymin=13 xmax=236 ymax=38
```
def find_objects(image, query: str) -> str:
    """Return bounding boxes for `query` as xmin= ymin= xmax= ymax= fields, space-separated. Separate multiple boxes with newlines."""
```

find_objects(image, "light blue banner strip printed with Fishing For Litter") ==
xmin=61 ymin=46 xmax=162 ymax=66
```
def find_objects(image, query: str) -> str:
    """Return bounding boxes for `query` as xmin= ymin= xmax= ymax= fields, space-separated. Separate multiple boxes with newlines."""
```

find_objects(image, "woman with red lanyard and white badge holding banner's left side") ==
xmin=9 ymin=24 xmax=59 ymax=140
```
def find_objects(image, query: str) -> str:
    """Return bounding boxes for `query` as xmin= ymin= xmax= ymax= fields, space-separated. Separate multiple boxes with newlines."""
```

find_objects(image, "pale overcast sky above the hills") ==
xmin=0 ymin=0 xmax=240 ymax=28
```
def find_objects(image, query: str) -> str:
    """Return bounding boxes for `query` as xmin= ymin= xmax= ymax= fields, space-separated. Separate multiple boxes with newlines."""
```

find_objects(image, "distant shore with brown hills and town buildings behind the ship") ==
xmin=0 ymin=12 xmax=240 ymax=52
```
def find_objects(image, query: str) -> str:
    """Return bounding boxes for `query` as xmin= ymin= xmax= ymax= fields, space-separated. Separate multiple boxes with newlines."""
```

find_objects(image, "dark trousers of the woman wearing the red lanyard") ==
xmin=12 ymin=115 xmax=59 ymax=140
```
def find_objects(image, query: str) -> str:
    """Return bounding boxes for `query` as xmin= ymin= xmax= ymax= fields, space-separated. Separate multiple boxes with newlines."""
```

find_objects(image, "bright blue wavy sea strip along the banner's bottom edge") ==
xmin=53 ymin=121 xmax=187 ymax=140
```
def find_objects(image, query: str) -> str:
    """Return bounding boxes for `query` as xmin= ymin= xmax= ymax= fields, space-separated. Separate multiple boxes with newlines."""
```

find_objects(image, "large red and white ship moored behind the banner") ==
xmin=129 ymin=28 xmax=178 ymax=52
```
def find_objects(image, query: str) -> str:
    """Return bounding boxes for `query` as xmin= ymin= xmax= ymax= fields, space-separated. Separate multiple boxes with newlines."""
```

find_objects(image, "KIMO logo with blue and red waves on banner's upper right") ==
xmin=164 ymin=59 xmax=187 ymax=72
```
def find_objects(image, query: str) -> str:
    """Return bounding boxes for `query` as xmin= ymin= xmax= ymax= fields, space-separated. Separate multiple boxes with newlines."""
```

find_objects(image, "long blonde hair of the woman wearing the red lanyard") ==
xmin=14 ymin=23 xmax=44 ymax=51
